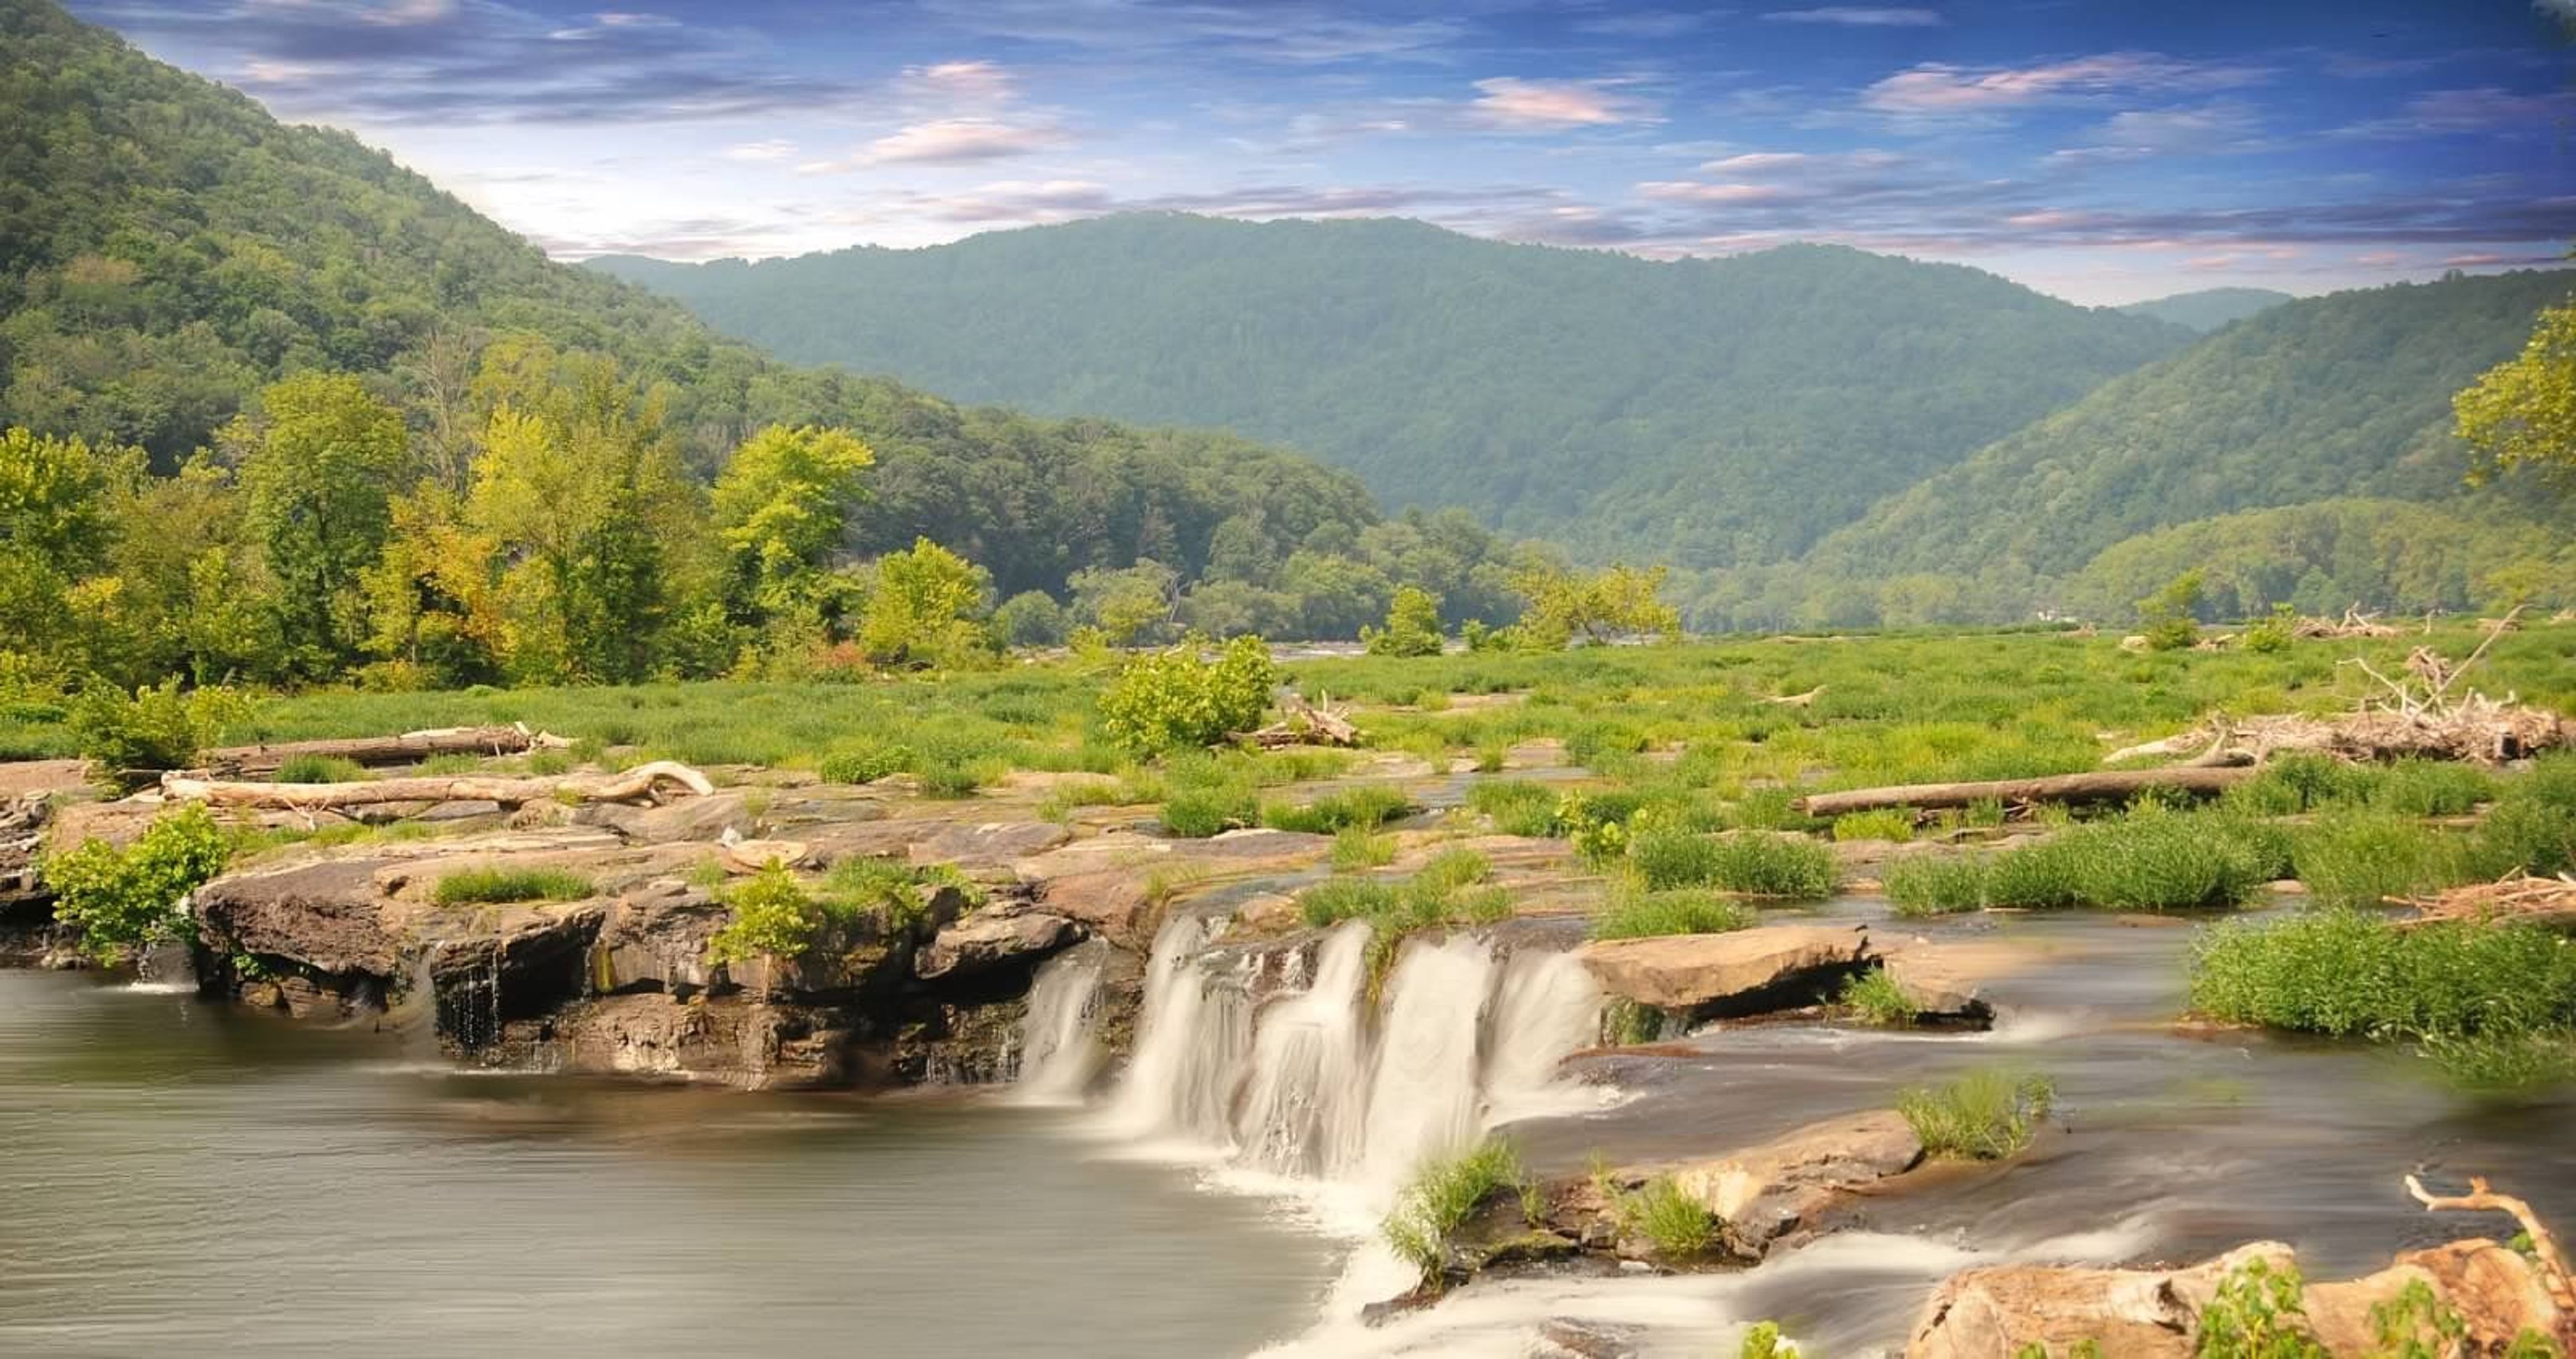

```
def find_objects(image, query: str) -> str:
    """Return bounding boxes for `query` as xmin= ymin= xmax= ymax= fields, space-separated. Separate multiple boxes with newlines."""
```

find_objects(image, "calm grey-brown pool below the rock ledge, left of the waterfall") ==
xmin=0 ymin=971 xmax=1334 ymax=1359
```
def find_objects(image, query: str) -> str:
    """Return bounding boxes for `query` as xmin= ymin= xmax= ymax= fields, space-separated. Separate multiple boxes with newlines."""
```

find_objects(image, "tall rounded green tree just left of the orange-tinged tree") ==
xmin=224 ymin=373 xmax=407 ymax=677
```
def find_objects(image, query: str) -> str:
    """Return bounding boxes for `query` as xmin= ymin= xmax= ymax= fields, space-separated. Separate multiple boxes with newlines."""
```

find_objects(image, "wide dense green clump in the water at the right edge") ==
xmin=2192 ymin=909 xmax=2576 ymax=1037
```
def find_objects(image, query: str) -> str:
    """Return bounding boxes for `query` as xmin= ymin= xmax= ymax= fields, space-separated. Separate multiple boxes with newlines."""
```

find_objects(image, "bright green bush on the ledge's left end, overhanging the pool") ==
xmin=39 ymin=806 xmax=232 ymax=963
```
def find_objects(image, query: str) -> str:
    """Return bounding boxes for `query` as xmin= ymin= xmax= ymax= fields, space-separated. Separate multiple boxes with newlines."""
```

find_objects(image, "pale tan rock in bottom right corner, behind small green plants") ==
xmin=1907 ymin=1240 xmax=2566 ymax=1359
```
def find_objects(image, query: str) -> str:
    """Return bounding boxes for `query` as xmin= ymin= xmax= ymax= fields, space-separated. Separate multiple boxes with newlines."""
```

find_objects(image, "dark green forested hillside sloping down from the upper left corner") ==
xmin=0 ymin=0 xmax=1378 ymax=600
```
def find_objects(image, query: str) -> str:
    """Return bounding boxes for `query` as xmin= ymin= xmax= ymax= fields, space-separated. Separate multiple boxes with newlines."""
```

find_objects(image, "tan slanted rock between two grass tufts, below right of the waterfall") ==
xmin=1666 ymin=1109 xmax=1924 ymax=1256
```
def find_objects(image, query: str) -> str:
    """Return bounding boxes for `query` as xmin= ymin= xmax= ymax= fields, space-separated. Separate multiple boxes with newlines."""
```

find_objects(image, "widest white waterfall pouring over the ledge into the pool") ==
xmin=1097 ymin=916 xmax=1600 ymax=1220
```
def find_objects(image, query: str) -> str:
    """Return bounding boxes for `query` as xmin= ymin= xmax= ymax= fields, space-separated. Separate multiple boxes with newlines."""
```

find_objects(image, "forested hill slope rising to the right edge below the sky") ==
xmin=1809 ymin=270 xmax=2576 ymax=597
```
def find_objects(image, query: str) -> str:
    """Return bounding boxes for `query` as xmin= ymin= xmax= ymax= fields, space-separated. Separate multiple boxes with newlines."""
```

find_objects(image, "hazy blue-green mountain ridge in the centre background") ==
xmin=592 ymin=213 xmax=2190 ymax=566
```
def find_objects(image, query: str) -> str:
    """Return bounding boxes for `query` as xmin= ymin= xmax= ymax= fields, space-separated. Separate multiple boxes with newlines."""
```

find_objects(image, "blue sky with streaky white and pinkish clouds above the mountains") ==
xmin=55 ymin=0 xmax=2576 ymax=304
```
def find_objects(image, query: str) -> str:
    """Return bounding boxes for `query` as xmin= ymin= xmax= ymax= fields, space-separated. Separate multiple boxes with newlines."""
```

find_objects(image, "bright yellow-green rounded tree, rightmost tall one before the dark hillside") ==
xmin=714 ymin=425 xmax=876 ymax=615
